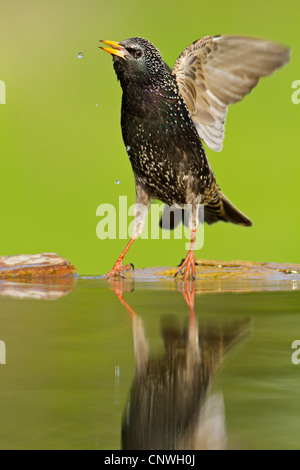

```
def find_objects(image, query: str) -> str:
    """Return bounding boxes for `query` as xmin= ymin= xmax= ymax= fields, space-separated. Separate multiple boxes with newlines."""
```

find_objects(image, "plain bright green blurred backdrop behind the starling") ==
xmin=0 ymin=0 xmax=300 ymax=274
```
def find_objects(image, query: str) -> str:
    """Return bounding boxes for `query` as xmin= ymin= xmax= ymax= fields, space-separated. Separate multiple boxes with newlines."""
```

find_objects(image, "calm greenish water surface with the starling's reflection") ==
xmin=0 ymin=278 xmax=300 ymax=449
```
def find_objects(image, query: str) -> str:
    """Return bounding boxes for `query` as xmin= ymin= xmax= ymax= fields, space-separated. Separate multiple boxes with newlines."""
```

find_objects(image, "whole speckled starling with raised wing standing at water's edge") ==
xmin=101 ymin=36 xmax=289 ymax=280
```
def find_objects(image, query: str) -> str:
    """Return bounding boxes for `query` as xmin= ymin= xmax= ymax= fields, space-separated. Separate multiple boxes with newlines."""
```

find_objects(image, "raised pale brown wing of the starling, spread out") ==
xmin=173 ymin=36 xmax=290 ymax=152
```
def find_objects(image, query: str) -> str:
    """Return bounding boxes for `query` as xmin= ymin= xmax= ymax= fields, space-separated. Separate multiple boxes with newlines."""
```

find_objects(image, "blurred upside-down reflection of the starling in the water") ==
xmin=110 ymin=280 xmax=250 ymax=450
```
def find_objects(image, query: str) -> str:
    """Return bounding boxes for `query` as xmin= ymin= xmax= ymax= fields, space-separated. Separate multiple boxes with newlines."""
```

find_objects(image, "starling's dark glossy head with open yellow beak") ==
xmin=101 ymin=37 xmax=169 ymax=88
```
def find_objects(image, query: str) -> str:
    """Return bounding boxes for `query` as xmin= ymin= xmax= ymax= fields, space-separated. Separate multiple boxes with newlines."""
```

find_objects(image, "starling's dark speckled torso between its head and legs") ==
xmin=121 ymin=59 xmax=214 ymax=205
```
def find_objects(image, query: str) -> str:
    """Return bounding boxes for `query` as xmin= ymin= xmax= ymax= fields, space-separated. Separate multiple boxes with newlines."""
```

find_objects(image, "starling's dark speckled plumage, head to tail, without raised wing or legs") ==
xmin=108 ymin=38 xmax=260 ymax=228
